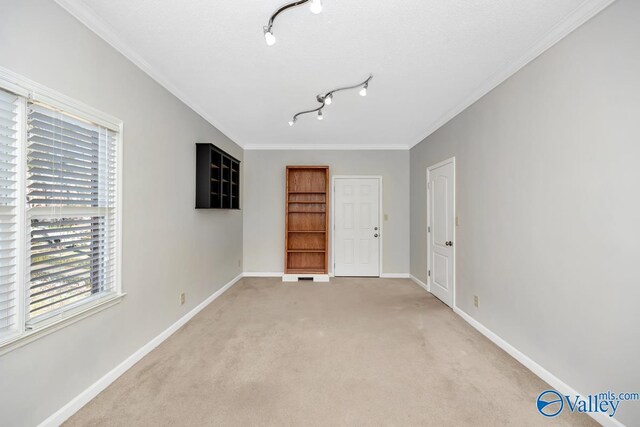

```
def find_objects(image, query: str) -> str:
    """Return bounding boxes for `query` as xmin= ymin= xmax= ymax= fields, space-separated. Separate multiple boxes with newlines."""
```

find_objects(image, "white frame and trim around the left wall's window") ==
xmin=0 ymin=67 xmax=126 ymax=355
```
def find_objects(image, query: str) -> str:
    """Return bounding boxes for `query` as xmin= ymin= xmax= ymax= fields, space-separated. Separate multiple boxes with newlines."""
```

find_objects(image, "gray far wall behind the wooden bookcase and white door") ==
xmin=243 ymin=150 xmax=409 ymax=273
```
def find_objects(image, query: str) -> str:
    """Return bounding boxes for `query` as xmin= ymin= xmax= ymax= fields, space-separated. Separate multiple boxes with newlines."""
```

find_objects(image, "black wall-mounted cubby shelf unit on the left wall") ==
xmin=196 ymin=144 xmax=240 ymax=209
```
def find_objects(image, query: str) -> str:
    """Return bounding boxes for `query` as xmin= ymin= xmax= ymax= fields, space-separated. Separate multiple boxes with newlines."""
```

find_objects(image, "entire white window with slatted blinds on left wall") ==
xmin=0 ymin=70 xmax=121 ymax=352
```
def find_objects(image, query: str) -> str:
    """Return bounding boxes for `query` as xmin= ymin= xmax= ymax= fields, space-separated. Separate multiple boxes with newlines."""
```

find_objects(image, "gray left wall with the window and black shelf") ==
xmin=0 ymin=0 xmax=242 ymax=426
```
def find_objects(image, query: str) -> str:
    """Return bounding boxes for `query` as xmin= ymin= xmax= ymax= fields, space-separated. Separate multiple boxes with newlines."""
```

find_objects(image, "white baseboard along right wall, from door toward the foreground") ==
xmin=453 ymin=306 xmax=624 ymax=427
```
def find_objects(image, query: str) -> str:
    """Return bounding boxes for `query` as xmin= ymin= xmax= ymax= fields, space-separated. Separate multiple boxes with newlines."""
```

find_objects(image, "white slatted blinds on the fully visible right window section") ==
xmin=27 ymin=103 xmax=116 ymax=321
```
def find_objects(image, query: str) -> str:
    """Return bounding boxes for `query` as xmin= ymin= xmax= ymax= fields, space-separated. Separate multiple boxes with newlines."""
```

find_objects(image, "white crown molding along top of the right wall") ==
xmin=409 ymin=0 xmax=615 ymax=149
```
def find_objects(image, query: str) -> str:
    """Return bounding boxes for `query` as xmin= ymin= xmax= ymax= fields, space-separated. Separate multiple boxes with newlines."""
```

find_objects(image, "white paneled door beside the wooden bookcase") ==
xmin=333 ymin=178 xmax=381 ymax=277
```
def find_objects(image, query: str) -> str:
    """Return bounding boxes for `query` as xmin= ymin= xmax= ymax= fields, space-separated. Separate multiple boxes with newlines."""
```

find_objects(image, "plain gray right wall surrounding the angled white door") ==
xmin=411 ymin=0 xmax=640 ymax=425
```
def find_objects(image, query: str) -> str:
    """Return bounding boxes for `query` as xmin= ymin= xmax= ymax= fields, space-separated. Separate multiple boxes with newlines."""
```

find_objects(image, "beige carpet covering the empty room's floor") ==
xmin=67 ymin=279 xmax=595 ymax=426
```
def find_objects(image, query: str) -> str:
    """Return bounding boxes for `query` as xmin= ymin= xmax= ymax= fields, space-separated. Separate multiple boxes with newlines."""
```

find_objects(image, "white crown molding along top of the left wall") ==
xmin=54 ymin=0 xmax=248 ymax=148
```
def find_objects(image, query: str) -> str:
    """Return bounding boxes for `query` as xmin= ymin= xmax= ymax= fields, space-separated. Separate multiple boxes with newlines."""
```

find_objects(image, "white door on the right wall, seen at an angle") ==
xmin=427 ymin=159 xmax=455 ymax=307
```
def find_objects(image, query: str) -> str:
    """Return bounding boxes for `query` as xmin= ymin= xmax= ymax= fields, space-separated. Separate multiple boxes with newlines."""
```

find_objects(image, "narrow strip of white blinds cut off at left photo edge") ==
xmin=0 ymin=90 xmax=18 ymax=340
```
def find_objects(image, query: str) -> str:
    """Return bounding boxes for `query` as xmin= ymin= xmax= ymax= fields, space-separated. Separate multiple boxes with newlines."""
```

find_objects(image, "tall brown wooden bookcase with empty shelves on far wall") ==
xmin=284 ymin=166 xmax=329 ymax=274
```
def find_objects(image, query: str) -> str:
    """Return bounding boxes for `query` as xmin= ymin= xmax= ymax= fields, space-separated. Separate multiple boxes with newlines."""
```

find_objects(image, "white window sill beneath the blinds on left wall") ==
xmin=0 ymin=293 xmax=127 ymax=356
